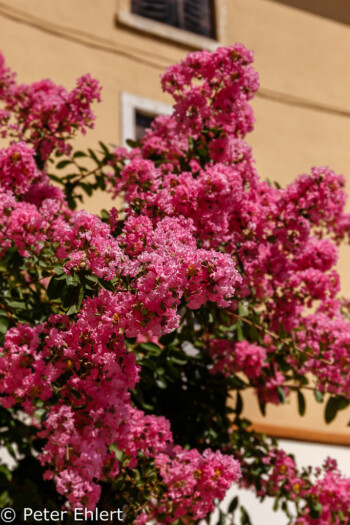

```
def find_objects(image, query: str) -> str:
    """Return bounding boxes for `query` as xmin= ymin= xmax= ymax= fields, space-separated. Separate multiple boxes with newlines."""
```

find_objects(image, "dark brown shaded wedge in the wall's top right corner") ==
xmin=272 ymin=0 xmax=350 ymax=25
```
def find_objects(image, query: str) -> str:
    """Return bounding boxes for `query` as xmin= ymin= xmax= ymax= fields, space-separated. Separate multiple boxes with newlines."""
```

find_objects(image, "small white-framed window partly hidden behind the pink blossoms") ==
xmin=121 ymin=92 xmax=172 ymax=146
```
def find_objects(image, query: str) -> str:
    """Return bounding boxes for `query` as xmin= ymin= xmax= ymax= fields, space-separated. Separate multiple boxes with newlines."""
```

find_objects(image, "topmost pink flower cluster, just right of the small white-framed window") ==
xmin=137 ymin=44 xmax=259 ymax=171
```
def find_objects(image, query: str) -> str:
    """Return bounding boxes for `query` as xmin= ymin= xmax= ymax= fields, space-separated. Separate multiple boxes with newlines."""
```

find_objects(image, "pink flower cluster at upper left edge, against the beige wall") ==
xmin=0 ymin=55 xmax=101 ymax=162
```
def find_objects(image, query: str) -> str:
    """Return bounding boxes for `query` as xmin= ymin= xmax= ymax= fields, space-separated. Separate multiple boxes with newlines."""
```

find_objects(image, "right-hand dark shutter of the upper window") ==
xmin=180 ymin=0 xmax=215 ymax=38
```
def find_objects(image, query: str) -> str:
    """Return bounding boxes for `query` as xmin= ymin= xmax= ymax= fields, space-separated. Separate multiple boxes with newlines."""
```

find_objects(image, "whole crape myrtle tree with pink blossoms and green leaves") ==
xmin=0 ymin=44 xmax=350 ymax=525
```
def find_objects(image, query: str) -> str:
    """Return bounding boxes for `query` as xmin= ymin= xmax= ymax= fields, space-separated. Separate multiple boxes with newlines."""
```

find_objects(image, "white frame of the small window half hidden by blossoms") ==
xmin=120 ymin=91 xmax=173 ymax=147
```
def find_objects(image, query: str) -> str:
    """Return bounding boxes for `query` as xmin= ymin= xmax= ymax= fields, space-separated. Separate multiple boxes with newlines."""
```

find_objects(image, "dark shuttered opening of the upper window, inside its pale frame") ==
xmin=131 ymin=0 xmax=216 ymax=38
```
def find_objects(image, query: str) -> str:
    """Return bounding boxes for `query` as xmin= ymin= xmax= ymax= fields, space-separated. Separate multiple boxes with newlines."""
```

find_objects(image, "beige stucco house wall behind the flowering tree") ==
xmin=0 ymin=0 xmax=350 ymax=438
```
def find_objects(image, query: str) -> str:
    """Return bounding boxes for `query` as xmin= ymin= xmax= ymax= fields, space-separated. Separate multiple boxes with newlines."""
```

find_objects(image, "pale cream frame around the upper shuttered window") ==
xmin=116 ymin=0 xmax=227 ymax=51
